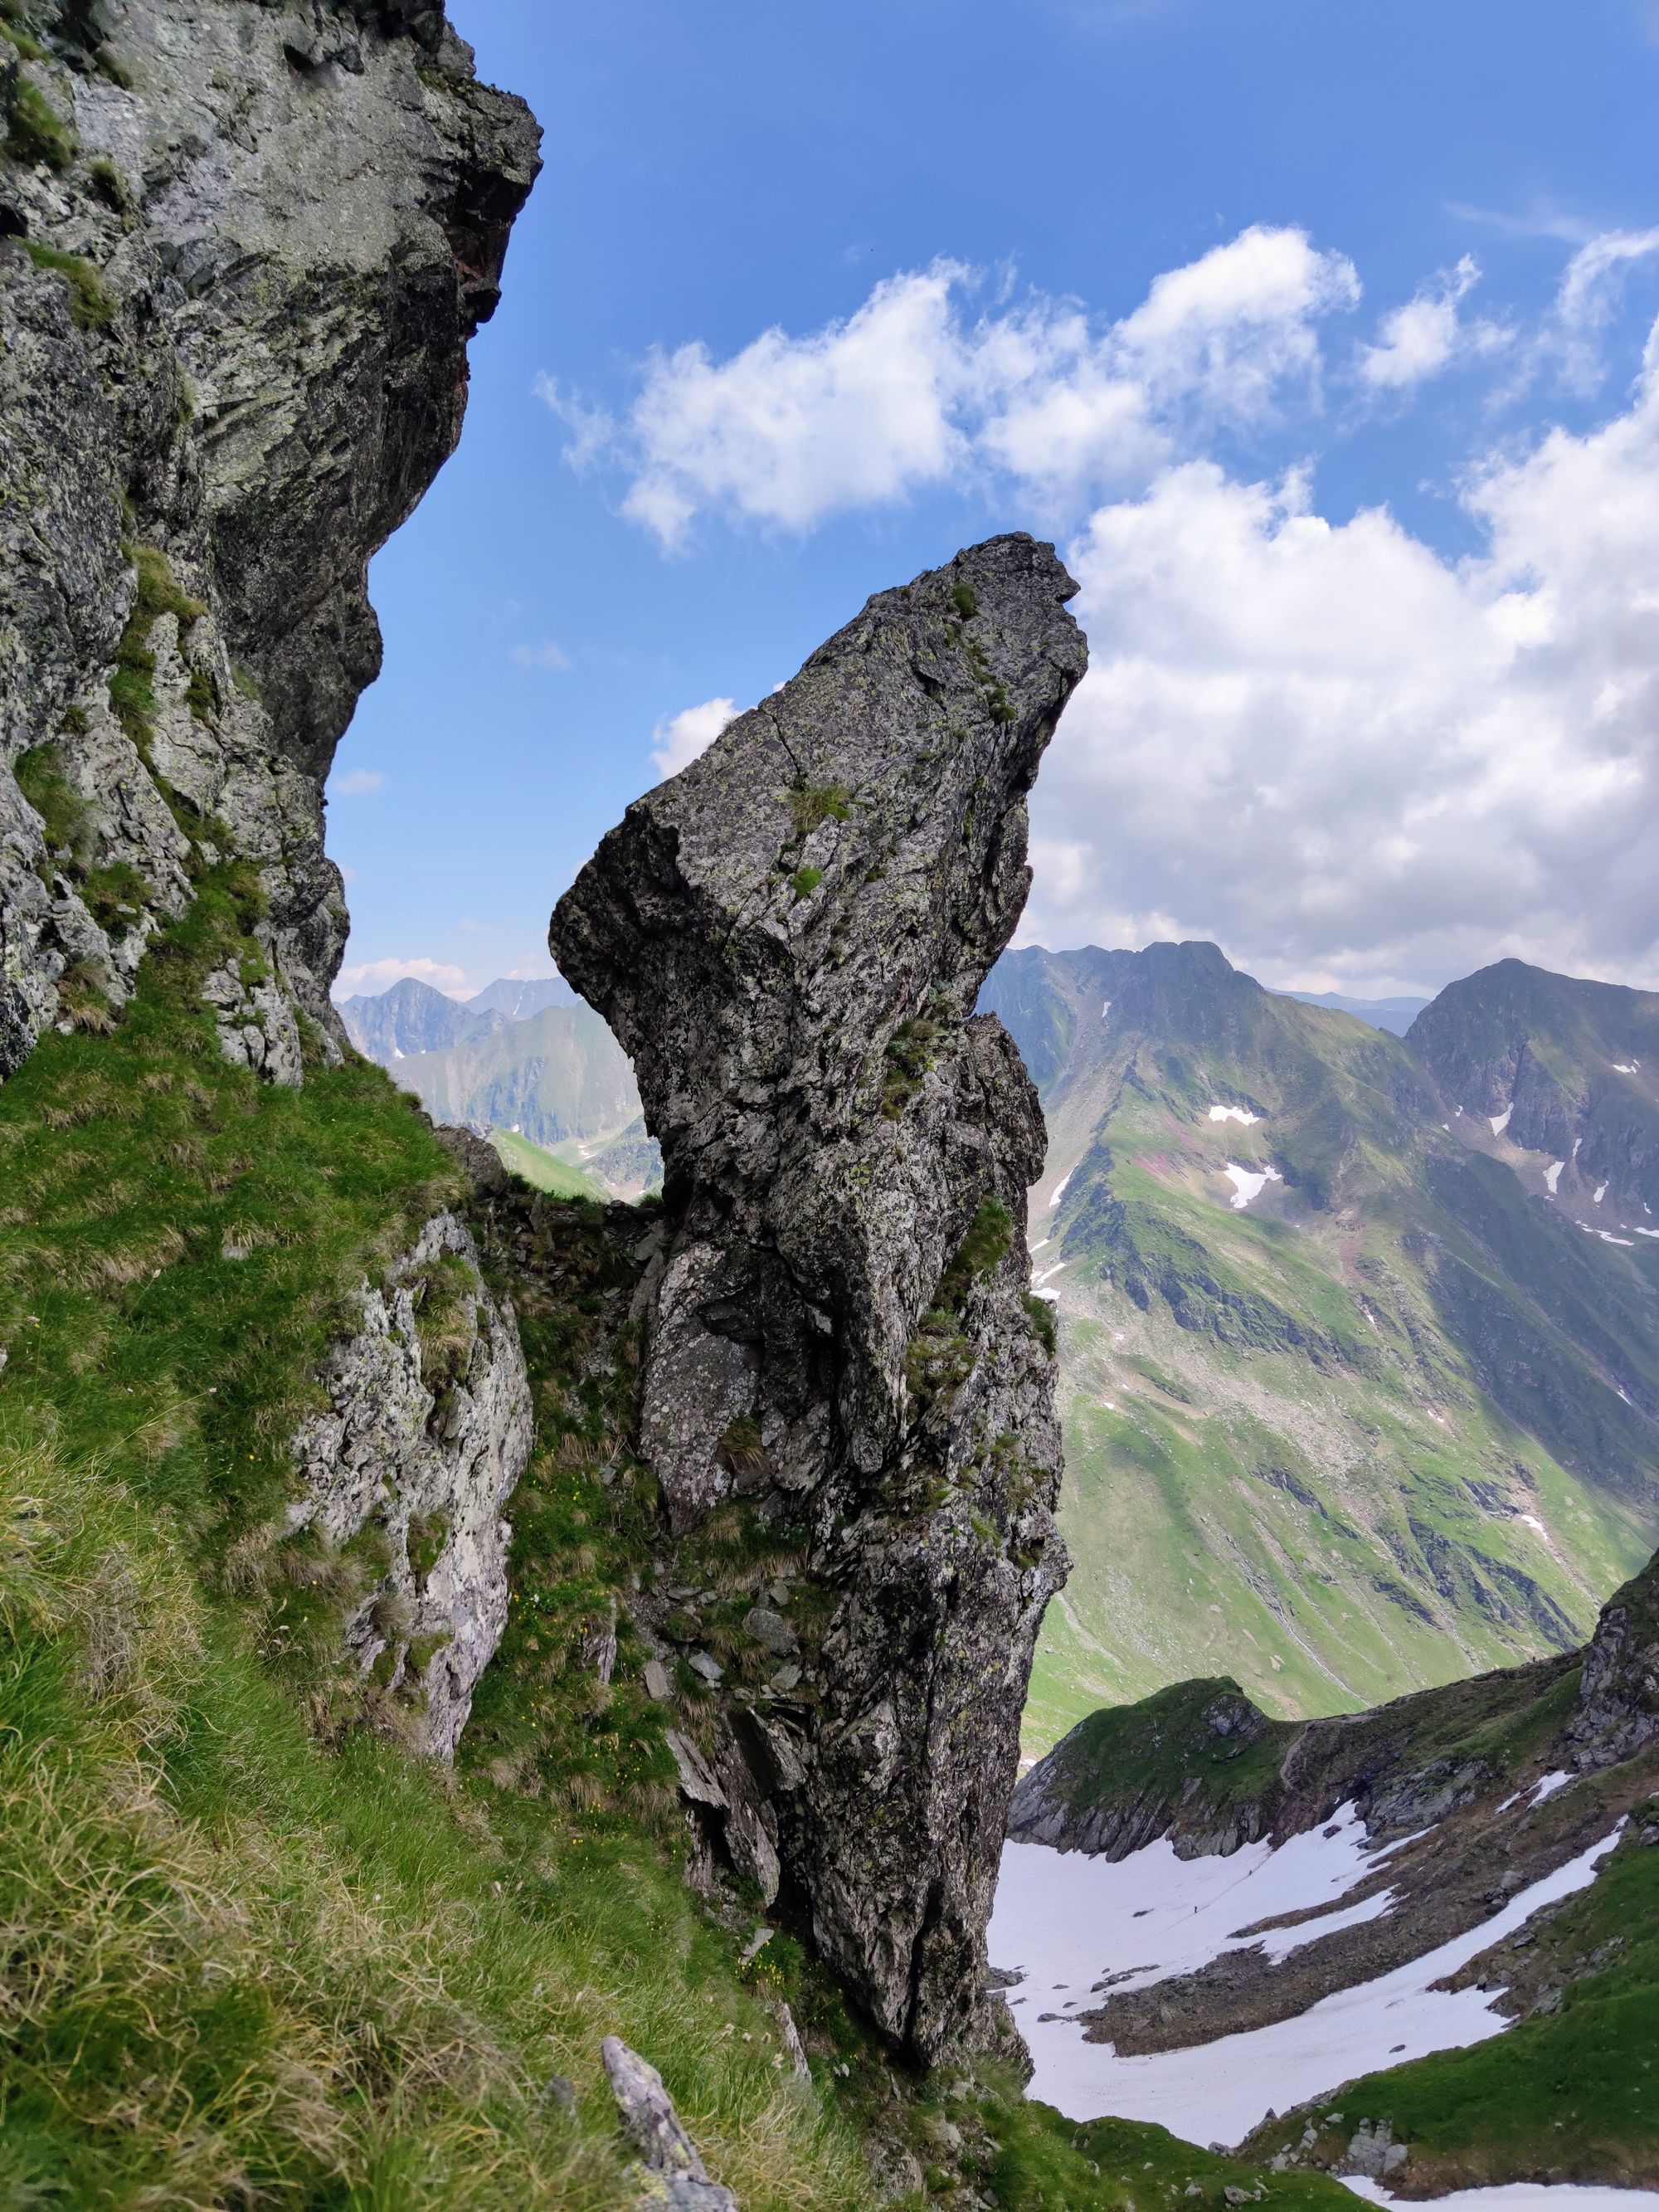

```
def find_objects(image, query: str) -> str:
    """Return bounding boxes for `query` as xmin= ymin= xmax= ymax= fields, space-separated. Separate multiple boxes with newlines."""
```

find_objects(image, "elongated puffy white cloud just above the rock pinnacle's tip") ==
xmin=538 ymin=226 xmax=1358 ymax=547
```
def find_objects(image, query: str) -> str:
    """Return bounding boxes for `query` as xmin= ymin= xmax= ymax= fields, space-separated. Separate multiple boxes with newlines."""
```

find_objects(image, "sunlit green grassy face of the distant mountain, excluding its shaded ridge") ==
xmin=1026 ymin=977 xmax=1655 ymax=1752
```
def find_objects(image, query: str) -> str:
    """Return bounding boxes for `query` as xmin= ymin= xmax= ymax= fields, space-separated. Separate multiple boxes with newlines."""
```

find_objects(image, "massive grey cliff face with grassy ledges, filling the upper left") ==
xmin=0 ymin=0 xmax=538 ymax=1082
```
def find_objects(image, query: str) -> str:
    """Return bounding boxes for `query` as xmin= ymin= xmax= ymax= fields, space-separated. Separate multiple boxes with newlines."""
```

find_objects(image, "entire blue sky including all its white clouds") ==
xmin=329 ymin=0 xmax=1659 ymax=991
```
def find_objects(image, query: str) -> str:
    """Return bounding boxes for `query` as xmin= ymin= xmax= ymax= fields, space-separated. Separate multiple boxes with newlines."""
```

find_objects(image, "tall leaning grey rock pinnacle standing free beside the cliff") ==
xmin=551 ymin=535 xmax=1086 ymax=2057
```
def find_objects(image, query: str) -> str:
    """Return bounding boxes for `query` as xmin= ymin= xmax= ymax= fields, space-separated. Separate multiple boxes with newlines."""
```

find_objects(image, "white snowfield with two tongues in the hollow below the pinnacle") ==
xmin=991 ymin=1807 xmax=1623 ymax=2143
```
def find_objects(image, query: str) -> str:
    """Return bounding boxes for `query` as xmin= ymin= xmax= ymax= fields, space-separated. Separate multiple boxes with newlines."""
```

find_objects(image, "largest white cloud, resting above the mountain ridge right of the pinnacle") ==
xmin=1022 ymin=320 xmax=1659 ymax=987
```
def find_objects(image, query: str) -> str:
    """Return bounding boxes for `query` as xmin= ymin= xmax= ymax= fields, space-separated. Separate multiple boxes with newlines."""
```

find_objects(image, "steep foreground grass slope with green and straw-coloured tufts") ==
xmin=0 ymin=889 xmax=1336 ymax=2212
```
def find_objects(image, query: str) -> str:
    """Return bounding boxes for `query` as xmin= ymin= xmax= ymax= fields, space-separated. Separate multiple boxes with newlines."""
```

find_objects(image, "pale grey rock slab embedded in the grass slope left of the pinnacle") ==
xmin=289 ymin=1215 xmax=533 ymax=1758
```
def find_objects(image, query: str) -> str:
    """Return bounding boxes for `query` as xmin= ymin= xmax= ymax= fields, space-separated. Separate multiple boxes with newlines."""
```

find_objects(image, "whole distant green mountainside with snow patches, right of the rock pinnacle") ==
xmin=985 ymin=944 xmax=1659 ymax=1750
